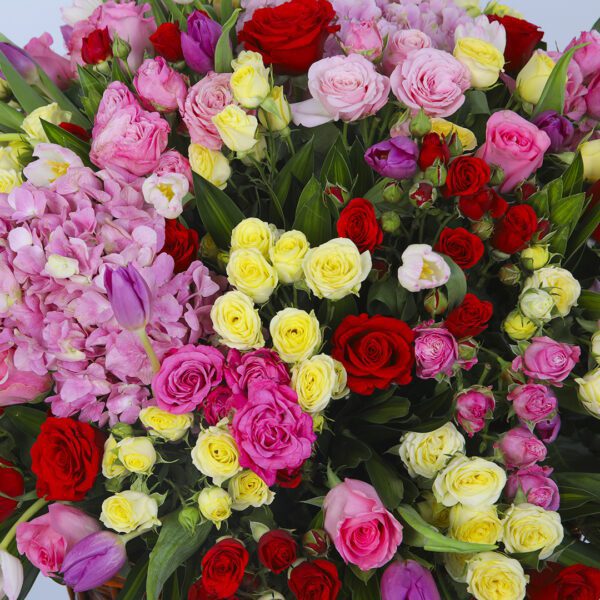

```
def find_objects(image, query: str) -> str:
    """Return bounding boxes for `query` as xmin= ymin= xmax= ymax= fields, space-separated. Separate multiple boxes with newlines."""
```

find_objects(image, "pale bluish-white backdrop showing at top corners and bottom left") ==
xmin=0 ymin=0 xmax=600 ymax=600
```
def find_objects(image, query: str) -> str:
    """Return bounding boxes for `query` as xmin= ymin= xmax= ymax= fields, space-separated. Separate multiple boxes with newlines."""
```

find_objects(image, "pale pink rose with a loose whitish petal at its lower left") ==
xmin=292 ymin=54 xmax=390 ymax=127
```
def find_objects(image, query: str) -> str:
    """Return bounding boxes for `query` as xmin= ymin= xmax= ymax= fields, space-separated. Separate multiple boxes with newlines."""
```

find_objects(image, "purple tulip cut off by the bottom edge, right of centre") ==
xmin=381 ymin=560 xmax=440 ymax=600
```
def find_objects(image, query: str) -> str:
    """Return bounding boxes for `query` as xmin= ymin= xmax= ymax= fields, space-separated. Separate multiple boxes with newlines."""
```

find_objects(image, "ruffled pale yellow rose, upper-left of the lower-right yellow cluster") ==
xmin=399 ymin=422 xmax=465 ymax=479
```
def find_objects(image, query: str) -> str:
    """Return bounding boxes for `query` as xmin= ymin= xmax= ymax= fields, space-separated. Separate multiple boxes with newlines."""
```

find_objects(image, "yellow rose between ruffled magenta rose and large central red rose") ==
xmin=292 ymin=354 xmax=337 ymax=414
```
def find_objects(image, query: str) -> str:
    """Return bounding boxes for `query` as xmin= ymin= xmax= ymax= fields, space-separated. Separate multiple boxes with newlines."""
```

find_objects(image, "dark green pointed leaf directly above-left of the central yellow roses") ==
xmin=193 ymin=173 xmax=244 ymax=249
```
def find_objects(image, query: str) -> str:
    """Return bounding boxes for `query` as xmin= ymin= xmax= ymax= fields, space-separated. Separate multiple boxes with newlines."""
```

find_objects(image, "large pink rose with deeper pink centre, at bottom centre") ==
xmin=323 ymin=479 xmax=402 ymax=571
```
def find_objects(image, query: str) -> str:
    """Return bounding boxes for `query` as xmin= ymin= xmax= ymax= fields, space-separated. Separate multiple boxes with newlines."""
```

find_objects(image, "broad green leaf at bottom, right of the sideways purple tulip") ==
xmin=146 ymin=512 xmax=212 ymax=600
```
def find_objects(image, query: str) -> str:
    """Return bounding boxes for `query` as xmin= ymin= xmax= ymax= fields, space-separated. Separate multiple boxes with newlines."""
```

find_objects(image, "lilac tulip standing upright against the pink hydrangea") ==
xmin=104 ymin=264 xmax=151 ymax=331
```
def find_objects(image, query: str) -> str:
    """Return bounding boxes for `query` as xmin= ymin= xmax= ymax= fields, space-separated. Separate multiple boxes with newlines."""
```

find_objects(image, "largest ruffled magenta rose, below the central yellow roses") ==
xmin=231 ymin=380 xmax=317 ymax=486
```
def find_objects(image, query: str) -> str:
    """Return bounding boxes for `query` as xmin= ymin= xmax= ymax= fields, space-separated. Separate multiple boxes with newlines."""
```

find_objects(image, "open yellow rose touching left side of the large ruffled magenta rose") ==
xmin=192 ymin=426 xmax=242 ymax=485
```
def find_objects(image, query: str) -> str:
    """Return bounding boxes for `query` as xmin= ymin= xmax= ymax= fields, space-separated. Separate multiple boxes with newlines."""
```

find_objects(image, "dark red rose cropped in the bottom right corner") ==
xmin=527 ymin=563 xmax=600 ymax=600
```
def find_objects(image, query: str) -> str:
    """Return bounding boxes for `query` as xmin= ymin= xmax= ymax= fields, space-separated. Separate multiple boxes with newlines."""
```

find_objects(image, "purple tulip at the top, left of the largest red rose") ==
xmin=181 ymin=10 xmax=222 ymax=73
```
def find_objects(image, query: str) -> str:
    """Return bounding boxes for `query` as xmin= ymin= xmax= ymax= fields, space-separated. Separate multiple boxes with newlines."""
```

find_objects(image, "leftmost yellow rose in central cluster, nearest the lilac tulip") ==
xmin=210 ymin=291 xmax=265 ymax=350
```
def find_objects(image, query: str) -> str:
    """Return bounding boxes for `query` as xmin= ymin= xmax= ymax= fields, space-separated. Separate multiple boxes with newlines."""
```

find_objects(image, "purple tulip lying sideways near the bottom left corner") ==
xmin=62 ymin=531 xmax=127 ymax=592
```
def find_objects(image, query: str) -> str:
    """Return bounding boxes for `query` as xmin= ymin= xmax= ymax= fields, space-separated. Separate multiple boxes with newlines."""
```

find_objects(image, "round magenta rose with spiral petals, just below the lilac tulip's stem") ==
xmin=152 ymin=344 xmax=225 ymax=415
